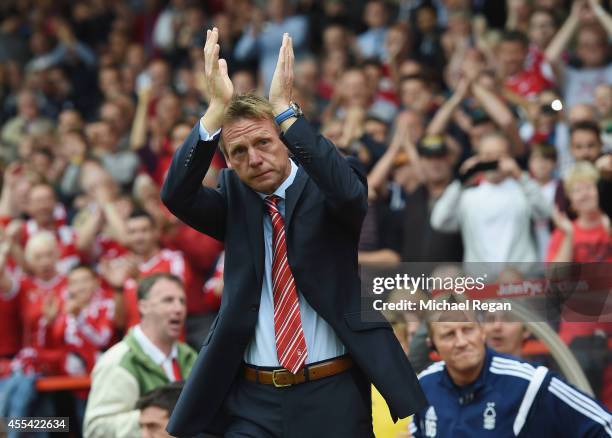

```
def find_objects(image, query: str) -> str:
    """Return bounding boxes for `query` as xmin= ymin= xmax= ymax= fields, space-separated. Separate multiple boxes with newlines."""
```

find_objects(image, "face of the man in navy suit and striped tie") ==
xmin=222 ymin=119 xmax=291 ymax=194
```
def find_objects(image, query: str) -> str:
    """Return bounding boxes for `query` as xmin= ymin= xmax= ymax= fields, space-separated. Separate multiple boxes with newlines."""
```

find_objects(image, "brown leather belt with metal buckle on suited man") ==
xmin=243 ymin=356 xmax=353 ymax=388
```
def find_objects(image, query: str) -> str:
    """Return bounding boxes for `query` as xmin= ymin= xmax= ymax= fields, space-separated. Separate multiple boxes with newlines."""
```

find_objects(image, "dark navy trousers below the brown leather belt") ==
xmin=224 ymin=367 xmax=374 ymax=438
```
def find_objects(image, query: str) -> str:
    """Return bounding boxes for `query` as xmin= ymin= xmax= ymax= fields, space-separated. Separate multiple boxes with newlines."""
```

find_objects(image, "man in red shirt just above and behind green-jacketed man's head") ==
xmin=102 ymin=210 xmax=192 ymax=328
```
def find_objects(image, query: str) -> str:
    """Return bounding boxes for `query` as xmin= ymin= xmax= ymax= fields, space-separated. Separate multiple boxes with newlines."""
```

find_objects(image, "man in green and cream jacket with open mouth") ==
xmin=84 ymin=273 xmax=197 ymax=438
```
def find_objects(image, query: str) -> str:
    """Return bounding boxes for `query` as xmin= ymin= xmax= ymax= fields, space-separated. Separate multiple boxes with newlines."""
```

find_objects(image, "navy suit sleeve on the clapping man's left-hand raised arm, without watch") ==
xmin=161 ymin=121 xmax=227 ymax=241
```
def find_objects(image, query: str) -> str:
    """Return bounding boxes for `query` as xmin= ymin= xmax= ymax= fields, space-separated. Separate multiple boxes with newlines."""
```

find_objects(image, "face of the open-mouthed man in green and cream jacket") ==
xmin=138 ymin=278 xmax=187 ymax=342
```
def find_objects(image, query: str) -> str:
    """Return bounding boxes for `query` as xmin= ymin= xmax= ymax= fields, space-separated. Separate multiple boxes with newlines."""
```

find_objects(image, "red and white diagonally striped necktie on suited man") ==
xmin=265 ymin=195 xmax=307 ymax=374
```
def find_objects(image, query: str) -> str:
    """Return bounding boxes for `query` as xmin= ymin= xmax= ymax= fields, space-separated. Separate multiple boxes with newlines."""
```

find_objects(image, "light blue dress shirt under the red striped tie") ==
xmin=200 ymin=123 xmax=346 ymax=367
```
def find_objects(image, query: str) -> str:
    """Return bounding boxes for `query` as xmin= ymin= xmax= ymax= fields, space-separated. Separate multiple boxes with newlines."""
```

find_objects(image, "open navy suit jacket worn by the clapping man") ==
xmin=161 ymin=118 xmax=427 ymax=436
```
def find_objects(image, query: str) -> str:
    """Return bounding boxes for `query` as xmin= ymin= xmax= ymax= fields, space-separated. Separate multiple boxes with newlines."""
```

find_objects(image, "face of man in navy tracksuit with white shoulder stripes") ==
xmin=432 ymin=322 xmax=485 ymax=374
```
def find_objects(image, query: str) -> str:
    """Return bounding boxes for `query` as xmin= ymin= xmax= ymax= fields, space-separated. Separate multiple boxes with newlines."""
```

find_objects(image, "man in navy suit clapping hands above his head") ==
xmin=162 ymin=28 xmax=427 ymax=438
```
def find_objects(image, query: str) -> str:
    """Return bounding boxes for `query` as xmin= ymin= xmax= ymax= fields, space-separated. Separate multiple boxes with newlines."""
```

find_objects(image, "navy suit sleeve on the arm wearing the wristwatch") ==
xmin=281 ymin=117 xmax=368 ymax=233
